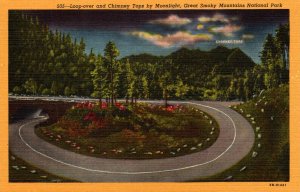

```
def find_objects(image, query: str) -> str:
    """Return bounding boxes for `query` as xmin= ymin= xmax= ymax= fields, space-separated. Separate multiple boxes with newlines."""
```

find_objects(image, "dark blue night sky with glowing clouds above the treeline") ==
xmin=24 ymin=10 xmax=289 ymax=63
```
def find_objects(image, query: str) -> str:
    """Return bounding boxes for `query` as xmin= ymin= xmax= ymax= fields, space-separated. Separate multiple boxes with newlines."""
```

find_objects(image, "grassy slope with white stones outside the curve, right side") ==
xmin=196 ymin=85 xmax=289 ymax=181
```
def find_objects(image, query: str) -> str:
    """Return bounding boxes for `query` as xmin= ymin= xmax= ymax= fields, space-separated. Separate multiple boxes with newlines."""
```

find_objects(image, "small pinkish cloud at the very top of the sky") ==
xmin=149 ymin=15 xmax=192 ymax=26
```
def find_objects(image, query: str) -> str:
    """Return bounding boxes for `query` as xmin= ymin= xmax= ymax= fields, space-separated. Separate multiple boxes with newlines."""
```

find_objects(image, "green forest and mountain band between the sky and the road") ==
xmin=9 ymin=11 xmax=289 ymax=103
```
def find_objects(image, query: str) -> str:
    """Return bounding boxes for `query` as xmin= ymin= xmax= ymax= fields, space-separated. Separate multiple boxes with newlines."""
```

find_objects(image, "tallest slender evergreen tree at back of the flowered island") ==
xmin=104 ymin=41 xmax=121 ymax=105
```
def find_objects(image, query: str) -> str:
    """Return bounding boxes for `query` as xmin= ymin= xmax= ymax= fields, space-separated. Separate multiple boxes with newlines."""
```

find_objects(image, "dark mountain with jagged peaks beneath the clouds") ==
xmin=123 ymin=46 xmax=255 ymax=76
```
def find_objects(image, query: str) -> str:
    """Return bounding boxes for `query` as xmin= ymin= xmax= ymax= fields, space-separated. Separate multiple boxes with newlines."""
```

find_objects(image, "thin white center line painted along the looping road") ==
xmin=19 ymin=102 xmax=236 ymax=175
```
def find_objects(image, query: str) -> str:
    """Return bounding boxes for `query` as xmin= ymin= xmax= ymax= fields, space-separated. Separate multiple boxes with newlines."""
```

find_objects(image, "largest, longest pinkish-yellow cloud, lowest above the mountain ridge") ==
xmin=130 ymin=31 xmax=213 ymax=48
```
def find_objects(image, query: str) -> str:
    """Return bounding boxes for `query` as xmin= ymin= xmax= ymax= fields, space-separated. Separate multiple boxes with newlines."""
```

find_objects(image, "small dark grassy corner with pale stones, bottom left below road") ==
xmin=9 ymin=153 xmax=78 ymax=183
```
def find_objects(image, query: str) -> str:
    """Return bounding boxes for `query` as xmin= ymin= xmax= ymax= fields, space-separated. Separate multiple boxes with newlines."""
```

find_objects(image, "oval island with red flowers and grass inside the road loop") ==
xmin=36 ymin=102 xmax=219 ymax=159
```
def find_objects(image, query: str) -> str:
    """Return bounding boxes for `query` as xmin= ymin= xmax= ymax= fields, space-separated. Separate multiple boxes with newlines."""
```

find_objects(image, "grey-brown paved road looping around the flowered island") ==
xmin=9 ymin=101 xmax=255 ymax=182
